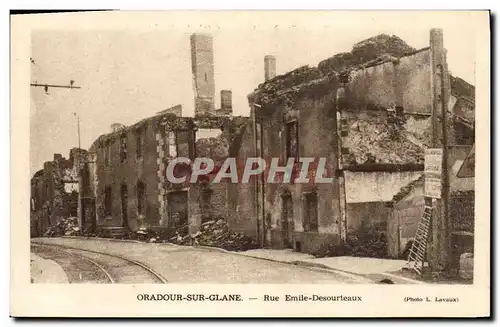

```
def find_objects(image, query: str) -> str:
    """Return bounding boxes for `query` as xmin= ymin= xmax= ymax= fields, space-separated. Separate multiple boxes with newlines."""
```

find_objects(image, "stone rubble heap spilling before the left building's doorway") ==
xmin=169 ymin=219 xmax=258 ymax=251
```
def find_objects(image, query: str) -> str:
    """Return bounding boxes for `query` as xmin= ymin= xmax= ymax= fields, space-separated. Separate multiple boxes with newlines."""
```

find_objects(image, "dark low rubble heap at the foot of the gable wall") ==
xmin=313 ymin=233 xmax=387 ymax=258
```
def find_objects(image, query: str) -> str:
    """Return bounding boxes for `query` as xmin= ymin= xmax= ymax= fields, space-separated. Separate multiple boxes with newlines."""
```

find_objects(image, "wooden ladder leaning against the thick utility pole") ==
xmin=408 ymin=205 xmax=432 ymax=275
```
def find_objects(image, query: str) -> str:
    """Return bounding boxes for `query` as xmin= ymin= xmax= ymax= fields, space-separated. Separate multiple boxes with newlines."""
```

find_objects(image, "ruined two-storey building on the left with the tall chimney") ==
xmin=78 ymin=34 xmax=248 ymax=238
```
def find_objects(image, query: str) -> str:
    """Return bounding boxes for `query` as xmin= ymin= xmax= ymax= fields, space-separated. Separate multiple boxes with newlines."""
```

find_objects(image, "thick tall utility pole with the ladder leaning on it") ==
xmin=428 ymin=29 xmax=451 ymax=275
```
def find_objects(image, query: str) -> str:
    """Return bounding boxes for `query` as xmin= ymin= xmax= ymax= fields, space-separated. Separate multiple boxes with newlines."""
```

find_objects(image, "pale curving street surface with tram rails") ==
xmin=31 ymin=238 xmax=366 ymax=284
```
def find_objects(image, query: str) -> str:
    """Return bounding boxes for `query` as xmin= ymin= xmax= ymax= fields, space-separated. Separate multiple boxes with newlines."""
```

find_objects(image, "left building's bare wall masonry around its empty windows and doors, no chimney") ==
xmin=94 ymin=113 xmax=248 ymax=236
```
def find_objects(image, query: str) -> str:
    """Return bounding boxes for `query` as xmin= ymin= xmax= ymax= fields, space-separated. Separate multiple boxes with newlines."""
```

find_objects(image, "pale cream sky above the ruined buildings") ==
xmin=30 ymin=14 xmax=475 ymax=174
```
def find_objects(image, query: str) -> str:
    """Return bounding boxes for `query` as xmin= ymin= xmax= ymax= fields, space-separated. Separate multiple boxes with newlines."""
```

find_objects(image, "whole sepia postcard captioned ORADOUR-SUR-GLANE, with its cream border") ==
xmin=11 ymin=11 xmax=491 ymax=317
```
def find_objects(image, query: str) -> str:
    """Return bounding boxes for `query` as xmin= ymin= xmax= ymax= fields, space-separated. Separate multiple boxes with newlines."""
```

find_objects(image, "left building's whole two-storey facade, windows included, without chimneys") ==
xmin=91 ymin=113 xmax=247 ymax=233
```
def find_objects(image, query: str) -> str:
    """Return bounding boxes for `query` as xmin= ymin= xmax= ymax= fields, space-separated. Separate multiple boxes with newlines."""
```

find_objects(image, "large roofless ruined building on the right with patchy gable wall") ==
xmin=243 ymin=30 xmax=474 ymax=253
